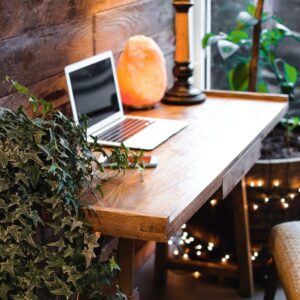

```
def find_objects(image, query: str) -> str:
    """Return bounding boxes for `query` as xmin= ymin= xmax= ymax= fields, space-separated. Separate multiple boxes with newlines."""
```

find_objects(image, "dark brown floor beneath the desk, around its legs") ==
xmin=135 ymin=256 xmax=286 ymax=300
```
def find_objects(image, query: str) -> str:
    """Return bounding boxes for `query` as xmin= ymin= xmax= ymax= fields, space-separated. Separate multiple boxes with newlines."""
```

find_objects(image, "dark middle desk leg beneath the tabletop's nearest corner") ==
xmin=154 ymin=243 xmax=169 ymax=287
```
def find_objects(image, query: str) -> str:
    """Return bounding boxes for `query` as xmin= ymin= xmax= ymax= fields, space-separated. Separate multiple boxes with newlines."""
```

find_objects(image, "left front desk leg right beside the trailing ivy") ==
xmin=118 ymin=238 xmax=139 ymax=300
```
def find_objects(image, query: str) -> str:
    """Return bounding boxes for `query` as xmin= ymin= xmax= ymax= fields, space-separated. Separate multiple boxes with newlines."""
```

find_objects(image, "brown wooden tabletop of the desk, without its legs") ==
xmin=83 ymin=93 xmax=287 ymax=242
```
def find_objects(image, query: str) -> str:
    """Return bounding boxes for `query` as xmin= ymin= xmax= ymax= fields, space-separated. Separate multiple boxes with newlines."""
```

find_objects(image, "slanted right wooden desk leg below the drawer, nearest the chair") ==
xmin=231 ymin=179 xmax=254 ymax=297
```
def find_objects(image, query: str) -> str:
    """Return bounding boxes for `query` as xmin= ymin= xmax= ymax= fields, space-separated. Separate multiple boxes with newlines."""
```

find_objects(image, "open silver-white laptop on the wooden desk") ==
xmin=65 ymin=51 xmax=187 ymax=150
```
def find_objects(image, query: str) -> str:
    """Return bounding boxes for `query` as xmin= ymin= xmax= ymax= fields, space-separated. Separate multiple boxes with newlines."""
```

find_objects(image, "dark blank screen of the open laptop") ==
xmin=69 ymin=58 xmax=120 ymax=127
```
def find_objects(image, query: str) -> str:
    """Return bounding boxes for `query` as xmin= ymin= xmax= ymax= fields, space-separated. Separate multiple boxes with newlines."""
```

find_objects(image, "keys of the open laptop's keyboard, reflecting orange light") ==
xmin=97 ymin=118 xmax=155 ymax=143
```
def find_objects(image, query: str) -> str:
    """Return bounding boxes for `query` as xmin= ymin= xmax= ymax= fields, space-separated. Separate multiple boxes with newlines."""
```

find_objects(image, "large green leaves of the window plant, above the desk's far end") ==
xmin=202 ymin=4 xmax=300 ymax=94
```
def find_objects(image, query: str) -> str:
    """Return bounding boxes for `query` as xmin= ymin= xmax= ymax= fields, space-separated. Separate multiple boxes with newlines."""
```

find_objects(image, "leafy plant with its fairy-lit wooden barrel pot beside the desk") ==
xmin=202 ymin=0 xmax=300 ymax=274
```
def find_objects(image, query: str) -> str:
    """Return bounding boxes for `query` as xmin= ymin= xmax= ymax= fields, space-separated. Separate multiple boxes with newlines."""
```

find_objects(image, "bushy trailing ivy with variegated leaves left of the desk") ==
xmin=0 ymin=78 xmax=141 ymax=300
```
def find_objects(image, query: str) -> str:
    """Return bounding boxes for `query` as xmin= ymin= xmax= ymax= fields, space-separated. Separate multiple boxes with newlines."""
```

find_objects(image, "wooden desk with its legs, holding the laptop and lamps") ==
xmin=84 ymin=91 xmax=288 ymax=298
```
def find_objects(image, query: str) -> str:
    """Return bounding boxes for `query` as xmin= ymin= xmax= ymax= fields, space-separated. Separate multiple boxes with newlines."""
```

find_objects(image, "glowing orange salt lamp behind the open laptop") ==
xmin=117 ymin=35 xmax=167 ymax=108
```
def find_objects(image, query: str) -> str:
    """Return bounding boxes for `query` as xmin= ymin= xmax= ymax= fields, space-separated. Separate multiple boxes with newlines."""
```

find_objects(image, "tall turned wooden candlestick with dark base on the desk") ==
xmin=162 ymin=0 xmax=206 ymax=105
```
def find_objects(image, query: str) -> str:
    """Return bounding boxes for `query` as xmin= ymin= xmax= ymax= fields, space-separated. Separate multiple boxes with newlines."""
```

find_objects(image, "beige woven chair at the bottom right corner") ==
xmin=264 ymin=222 xmax=300 ymax=300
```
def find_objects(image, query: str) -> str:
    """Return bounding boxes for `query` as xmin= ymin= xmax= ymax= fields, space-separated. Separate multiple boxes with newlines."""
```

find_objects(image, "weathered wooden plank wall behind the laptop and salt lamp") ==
xmin=0 ymin=0 xmax=174 ymax=114
